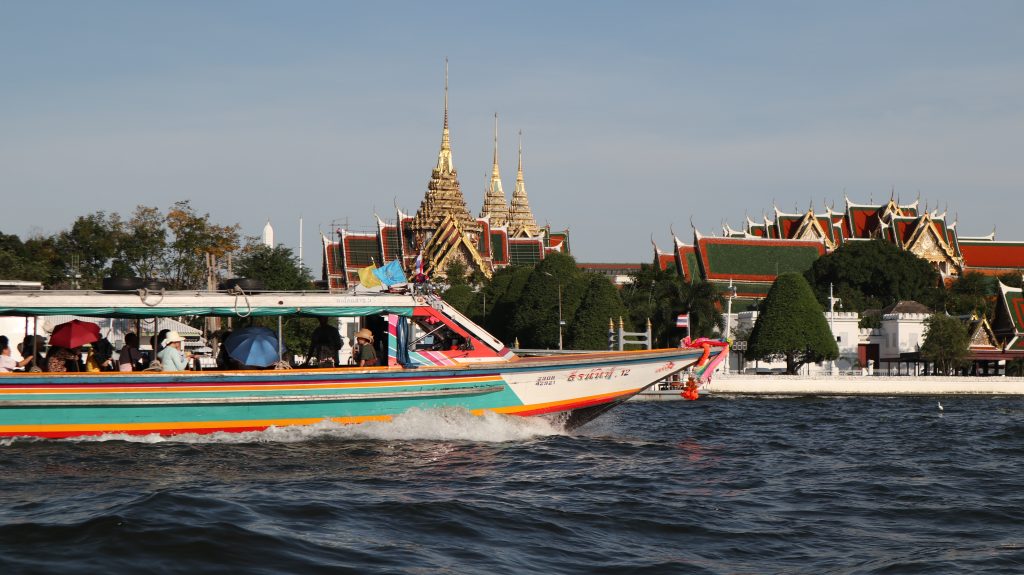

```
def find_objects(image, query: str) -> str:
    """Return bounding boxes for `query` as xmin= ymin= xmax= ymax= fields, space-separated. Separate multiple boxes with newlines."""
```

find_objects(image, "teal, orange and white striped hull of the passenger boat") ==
xmin=0 ymin=349 xmax=700 ymax=438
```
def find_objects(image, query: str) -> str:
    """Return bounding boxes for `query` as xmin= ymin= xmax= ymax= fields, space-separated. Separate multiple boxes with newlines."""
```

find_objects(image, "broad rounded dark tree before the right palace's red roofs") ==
xmin=805 ymin=239 xmax=942 ymax=311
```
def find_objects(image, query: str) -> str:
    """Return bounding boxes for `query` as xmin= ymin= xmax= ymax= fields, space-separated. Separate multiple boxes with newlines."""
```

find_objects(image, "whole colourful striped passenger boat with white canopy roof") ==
xmin=0 ymin=290 xmax=724 ymax=438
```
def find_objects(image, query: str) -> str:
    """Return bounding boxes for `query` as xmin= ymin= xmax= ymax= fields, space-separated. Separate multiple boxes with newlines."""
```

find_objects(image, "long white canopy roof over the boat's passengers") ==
xmin=0 ymin=290 xmax=423 ymax=317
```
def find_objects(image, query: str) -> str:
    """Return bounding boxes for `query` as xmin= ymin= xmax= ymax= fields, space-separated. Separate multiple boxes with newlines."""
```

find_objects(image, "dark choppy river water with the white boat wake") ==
xmin=0 ymin=397 xmax=1024 ymax=574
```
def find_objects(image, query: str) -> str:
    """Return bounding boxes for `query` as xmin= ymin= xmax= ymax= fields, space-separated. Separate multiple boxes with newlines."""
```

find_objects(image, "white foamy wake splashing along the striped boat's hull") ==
xmin=0 ymin=407 xmax=567 ymax=446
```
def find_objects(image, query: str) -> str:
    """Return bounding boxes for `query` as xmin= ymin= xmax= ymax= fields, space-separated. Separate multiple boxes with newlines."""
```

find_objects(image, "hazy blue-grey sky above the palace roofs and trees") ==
xmin=0 ymin=0 xmax=1024 ymax=270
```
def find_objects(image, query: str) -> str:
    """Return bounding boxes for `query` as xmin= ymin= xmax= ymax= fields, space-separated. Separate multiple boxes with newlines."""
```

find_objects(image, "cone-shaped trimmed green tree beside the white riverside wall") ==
xmin=746 ymin=273 xmax=839 ymax=374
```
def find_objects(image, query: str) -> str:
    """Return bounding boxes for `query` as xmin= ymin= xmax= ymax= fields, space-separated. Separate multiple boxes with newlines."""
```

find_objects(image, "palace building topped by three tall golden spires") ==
xmin=322 ymin=65 xmax=569 ymax=290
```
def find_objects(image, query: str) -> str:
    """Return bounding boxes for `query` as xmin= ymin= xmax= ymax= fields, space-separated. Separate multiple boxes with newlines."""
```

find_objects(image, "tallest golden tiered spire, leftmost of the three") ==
xmin=412 ymin=58 xmax=480 ymax=235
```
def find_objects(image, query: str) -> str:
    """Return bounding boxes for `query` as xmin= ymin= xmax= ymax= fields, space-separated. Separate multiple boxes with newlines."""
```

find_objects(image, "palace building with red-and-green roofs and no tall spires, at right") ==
xmin=654 ymin=196 xmax=1024 ymax=304
